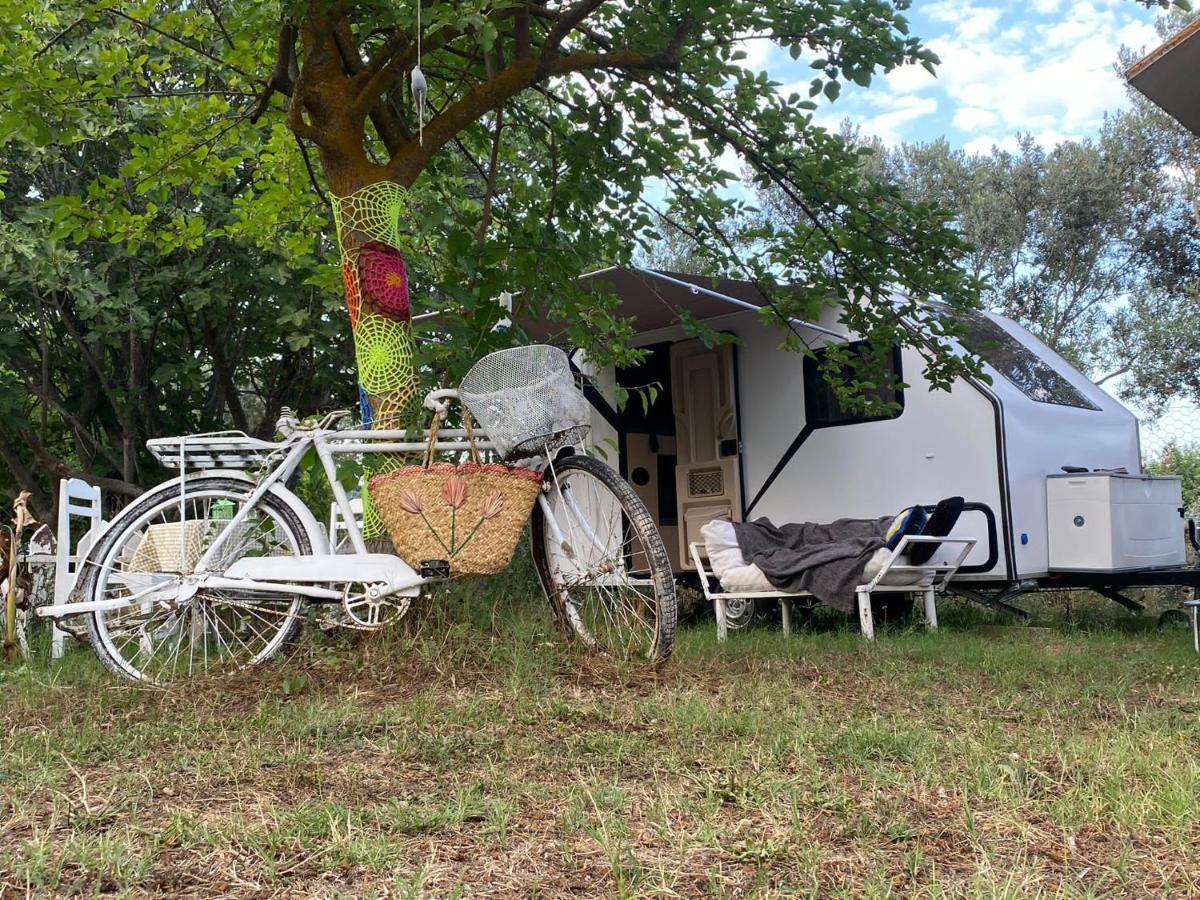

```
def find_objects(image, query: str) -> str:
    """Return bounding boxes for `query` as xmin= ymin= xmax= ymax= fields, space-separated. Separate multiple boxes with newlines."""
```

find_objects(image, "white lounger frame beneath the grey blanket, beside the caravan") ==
xmin=689 ymin=535 xmax=976 ymax=641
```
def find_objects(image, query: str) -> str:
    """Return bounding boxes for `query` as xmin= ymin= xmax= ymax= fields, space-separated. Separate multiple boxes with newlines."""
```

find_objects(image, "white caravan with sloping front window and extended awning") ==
xmin=522 ymin=268 xmax=1140 ymax=587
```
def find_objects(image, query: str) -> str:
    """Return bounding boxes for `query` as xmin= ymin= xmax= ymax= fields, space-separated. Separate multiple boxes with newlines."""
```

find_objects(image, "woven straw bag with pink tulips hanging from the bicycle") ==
xmin=367 ymin=415 xmax=541 ymax=577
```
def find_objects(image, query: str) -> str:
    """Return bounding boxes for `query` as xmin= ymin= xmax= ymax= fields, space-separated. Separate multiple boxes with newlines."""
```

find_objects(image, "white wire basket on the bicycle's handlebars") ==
xmin=458 ymin=344 xmax=592 ymax=460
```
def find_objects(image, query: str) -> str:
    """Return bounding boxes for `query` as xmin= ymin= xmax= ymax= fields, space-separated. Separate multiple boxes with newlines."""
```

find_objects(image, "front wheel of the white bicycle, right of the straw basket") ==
xmin=533 ymin=456 xmax=677 ymax=664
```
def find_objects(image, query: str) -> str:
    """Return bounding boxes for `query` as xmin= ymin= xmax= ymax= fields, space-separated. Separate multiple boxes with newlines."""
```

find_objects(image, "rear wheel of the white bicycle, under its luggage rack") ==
xmin=80 ymin=478 xmax=312 ymax=686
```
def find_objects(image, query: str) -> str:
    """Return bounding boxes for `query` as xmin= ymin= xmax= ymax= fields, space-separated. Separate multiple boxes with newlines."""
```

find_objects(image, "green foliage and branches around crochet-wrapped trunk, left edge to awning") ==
xmin=0 ymin=0 xmax=1180 ymax=510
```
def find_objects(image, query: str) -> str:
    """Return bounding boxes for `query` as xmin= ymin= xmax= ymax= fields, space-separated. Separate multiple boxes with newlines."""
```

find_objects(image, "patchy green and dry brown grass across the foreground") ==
xmin=0 ymin=578 xmax=1200 ymax=898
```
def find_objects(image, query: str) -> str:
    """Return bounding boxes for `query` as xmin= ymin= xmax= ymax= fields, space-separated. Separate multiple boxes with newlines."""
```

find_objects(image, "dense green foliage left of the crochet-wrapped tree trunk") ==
xmin=0 ymin=0 xmax=354 ymax=508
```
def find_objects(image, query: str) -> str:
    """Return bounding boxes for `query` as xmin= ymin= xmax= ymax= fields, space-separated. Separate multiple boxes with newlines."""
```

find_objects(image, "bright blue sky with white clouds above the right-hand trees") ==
xmin=749 ymin=0 xmax=1159 ymax=152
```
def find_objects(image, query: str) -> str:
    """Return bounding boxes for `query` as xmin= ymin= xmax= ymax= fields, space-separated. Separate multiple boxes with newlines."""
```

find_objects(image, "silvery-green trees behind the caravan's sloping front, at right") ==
xmin=859 ymin=109 xmax=1200 ymax=420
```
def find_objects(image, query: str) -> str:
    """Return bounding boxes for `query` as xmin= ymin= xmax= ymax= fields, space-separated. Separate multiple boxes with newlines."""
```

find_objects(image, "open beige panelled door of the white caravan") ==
xmin=671 ymin=341 xmax=742 ymax=569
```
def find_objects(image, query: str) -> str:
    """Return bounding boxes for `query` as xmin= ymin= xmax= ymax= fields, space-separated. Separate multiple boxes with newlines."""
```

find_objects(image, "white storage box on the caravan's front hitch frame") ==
xmin=1046 ymin=472 xmax=1186 ymax=572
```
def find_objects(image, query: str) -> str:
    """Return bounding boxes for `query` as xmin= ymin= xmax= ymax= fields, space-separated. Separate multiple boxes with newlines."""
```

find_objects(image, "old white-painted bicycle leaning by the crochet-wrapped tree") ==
xmin=40 ymin=350 xmax=676 ymax=685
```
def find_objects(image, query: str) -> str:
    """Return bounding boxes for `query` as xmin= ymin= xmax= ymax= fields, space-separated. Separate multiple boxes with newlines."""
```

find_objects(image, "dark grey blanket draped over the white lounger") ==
xmin=733 ymin=516 xmax=892 ymax=612
